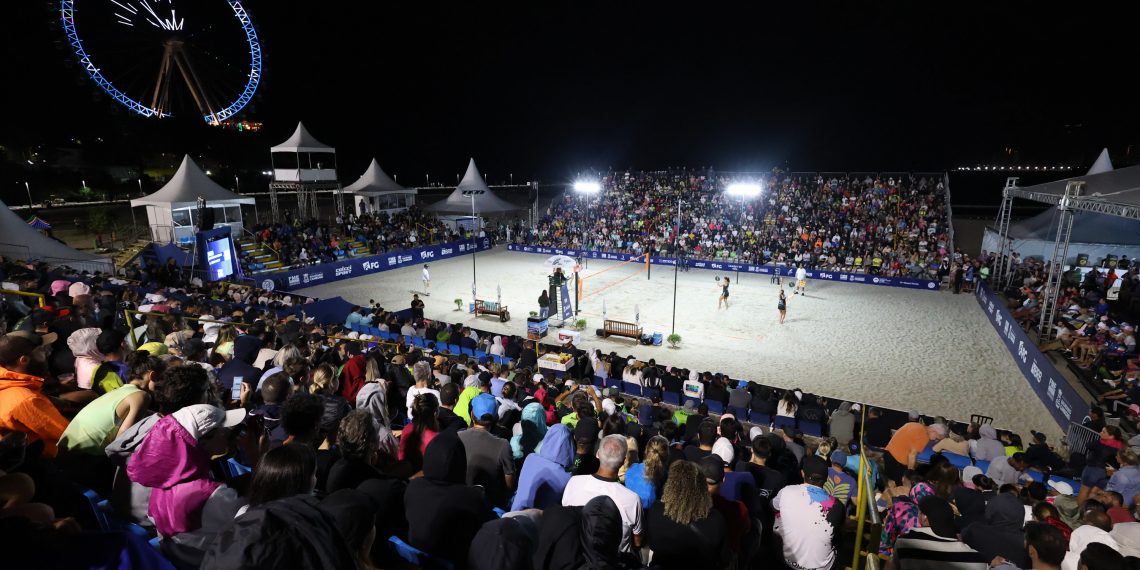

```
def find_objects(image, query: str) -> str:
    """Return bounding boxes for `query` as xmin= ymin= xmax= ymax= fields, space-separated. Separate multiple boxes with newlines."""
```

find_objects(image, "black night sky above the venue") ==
xmin=0 ymin=0 xmax=1140 ymax=182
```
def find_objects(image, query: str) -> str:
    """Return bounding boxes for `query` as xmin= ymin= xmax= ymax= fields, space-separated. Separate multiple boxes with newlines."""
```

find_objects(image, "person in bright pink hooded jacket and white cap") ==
xmin=127 ymin=404 xmax=246 ymax=549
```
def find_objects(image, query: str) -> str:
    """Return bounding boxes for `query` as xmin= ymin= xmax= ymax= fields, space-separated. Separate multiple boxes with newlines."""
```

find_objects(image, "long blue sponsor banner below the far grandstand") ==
xmin=506 ymin=244 xmax=938 ymax=291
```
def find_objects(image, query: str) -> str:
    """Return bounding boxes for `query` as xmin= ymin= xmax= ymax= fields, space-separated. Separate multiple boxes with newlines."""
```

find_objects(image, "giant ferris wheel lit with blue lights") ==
xmin=59 ymin=0 xmax=261 ymax=124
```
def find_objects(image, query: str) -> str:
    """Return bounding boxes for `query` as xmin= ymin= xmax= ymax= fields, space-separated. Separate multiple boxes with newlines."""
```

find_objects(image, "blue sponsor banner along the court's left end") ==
xmin=272 ymin=237 xmax=490 ymax=291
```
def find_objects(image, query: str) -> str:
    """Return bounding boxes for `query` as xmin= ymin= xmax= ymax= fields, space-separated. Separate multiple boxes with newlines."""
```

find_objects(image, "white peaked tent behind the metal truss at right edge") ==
xmin=982 ymin=148 xmax=1140 ymax=264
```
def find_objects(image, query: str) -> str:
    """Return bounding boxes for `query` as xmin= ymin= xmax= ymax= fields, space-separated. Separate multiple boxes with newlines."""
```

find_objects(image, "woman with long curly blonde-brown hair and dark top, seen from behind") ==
xmin=645 ymin=461 xmax=726 ymax=569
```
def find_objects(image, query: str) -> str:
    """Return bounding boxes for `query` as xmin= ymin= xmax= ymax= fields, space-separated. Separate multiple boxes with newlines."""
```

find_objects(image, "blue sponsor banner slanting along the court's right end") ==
xmin=975 ymin=283 xmax=1089 ymax=431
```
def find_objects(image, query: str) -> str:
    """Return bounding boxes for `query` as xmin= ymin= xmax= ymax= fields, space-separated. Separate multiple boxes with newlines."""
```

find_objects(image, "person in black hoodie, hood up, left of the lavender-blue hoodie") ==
xmin=405 ymin=431 xmax=494 ymax=567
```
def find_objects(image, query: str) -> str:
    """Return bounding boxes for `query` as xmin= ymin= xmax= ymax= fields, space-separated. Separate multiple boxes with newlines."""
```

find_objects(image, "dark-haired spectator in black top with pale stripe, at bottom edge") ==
xmin=893 ymin=496 xmax=990 ymax=570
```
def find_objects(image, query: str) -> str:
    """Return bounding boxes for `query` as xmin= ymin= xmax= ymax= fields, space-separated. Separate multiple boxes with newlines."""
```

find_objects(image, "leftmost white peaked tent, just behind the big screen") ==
xmin=131 ymin=155 xmax=254 ymax=243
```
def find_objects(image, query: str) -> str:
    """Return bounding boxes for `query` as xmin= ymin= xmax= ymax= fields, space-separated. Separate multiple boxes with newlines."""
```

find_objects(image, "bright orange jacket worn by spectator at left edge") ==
xmin=0 ymin=368 xmax=68 ymax=457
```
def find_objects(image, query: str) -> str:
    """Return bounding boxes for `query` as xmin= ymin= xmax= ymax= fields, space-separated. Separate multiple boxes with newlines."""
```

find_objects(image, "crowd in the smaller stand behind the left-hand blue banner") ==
xmin=242 ymin=206 xmax=458 ymax=270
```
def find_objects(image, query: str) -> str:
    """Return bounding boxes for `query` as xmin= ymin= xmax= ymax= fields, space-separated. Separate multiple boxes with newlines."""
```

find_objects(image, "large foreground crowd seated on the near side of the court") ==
xmin=0 ymin=254 xmax=1140 ymax=569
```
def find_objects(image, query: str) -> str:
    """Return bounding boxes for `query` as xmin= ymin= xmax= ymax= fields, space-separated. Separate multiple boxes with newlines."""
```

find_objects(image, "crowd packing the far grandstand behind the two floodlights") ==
xmin=515 ymin=170 xmax=951 ymax=277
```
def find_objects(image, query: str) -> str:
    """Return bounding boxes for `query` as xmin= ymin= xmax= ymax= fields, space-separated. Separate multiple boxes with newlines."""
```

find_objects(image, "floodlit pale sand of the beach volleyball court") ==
xmin=299 ymin=247 xmax=1062 ymax=441
